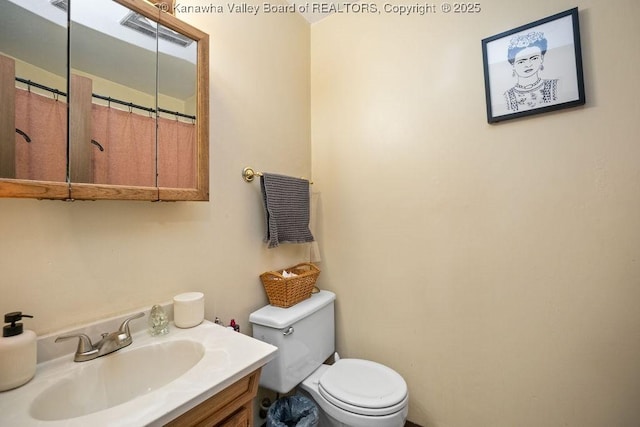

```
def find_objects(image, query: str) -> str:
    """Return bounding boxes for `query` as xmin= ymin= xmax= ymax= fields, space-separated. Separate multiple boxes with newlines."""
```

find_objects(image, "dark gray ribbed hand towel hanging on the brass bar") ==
xmin=260 ymin=173 xmax=314 ymax=248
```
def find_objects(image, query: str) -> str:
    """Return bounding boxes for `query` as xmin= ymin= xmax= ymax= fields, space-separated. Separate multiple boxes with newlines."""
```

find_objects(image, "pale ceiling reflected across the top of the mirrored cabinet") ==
xmin=0 ymin=0 xmax=197 ymax=99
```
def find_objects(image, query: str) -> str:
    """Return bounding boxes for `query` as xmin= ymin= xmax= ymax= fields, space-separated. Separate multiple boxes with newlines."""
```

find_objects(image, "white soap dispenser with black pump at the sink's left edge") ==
xmin=0 ymin=311 xmax=38 ymax=391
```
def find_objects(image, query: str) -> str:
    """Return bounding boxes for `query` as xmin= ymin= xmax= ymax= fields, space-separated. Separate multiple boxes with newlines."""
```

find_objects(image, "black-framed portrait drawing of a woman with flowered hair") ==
xmin=482 ymin=8 xmax=585 ymax=123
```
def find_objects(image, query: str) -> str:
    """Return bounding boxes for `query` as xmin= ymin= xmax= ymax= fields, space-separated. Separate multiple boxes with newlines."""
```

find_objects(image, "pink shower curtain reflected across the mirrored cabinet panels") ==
xmin=15 ymin=88 xmax=197 ymax=188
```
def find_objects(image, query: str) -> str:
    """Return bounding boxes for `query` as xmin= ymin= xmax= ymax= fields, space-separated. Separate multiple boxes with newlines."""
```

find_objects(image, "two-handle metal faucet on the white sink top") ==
xmin=56 ymin=313 xmax=144 ymax=362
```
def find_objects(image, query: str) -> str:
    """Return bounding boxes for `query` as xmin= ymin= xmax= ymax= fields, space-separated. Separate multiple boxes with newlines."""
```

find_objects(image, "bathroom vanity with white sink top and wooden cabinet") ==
xmin=0 ymin=310 xmax=277 ymax=427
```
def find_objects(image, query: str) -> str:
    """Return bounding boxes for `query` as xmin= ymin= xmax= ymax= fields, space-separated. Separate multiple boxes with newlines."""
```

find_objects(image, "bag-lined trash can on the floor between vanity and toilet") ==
xmin=267 ymin=395 xmax=320 ymax=427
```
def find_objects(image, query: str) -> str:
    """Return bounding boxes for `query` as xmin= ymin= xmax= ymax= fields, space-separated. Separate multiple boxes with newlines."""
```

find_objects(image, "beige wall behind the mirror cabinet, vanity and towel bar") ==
xmin=0 ymin=3 xmax=311 ymax=333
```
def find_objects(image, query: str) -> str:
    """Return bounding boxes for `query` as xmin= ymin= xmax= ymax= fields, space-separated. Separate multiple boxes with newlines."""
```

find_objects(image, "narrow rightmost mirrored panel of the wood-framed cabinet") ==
xmin=158 ymin=25 xmax=198 ymax=188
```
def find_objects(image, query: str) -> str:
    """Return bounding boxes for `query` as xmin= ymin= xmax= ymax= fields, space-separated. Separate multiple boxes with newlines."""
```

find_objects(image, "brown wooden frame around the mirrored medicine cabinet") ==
xmin=0 ymin=0 xmax=209 ymax=201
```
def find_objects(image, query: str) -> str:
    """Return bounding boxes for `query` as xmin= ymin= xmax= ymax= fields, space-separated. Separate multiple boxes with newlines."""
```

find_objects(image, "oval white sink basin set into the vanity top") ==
xmin=30 ymin=340 xmax=204 ymax=421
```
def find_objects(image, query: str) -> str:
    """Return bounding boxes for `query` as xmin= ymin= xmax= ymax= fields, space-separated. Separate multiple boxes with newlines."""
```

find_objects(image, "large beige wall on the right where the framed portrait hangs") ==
xmin=311 ymin=0 xmax=640 ymax=427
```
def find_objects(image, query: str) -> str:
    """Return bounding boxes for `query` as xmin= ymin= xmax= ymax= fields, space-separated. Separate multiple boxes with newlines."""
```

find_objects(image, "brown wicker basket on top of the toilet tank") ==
xmin=260 ymin=262 xmax=320 ymax=308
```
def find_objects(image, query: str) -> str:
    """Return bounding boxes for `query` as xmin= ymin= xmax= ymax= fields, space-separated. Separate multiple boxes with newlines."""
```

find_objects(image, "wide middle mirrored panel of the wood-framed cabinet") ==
xmin=69 ymin=0 xmax=157 ymax=187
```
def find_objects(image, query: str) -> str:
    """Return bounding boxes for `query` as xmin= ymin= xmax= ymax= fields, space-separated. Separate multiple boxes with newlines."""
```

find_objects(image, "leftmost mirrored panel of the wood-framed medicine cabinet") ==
xmin=0 ymin=0 xmax=67 ymax=182
